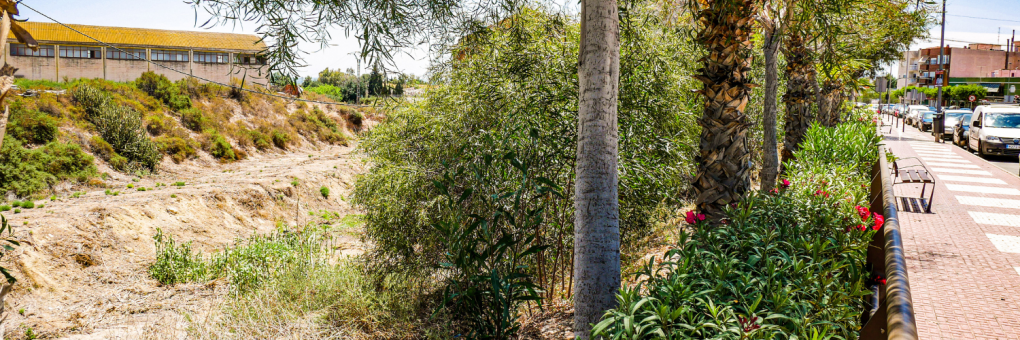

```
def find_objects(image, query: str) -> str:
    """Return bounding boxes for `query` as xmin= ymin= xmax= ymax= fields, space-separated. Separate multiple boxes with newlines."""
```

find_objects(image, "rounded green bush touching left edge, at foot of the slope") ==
xmin=0 ymin=138 xmax=97 ymax=196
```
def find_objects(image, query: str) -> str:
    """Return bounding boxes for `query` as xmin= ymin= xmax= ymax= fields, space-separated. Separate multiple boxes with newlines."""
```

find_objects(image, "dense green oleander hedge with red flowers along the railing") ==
xmin=594 ymin=120 xmax=881 ymax=339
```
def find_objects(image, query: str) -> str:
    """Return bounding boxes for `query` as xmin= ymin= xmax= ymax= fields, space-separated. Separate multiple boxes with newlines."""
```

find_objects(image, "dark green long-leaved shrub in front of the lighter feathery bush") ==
xmin=432 ymin=152 xmax=563 ymax=339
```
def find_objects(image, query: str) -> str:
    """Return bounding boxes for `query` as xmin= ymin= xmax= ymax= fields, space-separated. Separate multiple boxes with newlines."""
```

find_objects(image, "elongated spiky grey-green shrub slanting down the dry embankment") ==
xmin=72 ymin=84 xmax=162 ymax=169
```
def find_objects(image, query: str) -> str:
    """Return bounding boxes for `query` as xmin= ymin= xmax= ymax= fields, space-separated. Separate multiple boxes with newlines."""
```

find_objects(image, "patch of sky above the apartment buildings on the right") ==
xmin=886 ymin=0 xmax=1020 ymax=75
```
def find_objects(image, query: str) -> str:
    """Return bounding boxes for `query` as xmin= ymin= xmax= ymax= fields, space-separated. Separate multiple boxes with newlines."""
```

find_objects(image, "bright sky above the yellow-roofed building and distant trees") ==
xmin=18 ymin=0 xmax=428 ymax=78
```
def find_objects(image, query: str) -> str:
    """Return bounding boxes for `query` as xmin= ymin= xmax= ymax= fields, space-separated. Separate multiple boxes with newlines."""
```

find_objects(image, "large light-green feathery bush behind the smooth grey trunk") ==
xmin=353 ymin=10 xmax=698 ymax=291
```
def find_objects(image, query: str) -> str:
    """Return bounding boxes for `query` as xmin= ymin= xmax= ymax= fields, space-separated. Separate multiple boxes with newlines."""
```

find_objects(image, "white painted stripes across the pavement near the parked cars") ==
xmin=910 ymin=142 xmax=1020 ymax=275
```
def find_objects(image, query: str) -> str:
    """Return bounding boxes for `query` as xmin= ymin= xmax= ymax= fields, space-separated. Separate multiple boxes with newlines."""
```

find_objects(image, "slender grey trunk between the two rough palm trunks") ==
xmin=761 ymin=32 xmax=781 ymax=190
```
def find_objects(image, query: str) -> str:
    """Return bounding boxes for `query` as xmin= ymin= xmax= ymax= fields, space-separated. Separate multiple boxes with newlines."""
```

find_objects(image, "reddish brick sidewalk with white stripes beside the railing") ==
xmin=885 ymin=115 xmax=1020 ymax=340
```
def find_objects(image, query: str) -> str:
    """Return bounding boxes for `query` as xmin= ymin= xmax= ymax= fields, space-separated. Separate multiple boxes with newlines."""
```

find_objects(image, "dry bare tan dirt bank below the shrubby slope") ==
xmin=3 ymin=139 xmax=366 ymax=339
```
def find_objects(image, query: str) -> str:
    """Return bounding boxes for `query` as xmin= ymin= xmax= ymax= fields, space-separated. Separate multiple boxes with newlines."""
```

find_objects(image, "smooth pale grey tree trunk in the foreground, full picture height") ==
xmin=574 ymin=0 xmax=620 ymax=339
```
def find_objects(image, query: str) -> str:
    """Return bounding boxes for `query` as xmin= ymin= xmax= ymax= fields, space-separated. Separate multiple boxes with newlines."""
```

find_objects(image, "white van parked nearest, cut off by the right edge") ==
xmin=967 ymin=105 xmax=1020 ymax=156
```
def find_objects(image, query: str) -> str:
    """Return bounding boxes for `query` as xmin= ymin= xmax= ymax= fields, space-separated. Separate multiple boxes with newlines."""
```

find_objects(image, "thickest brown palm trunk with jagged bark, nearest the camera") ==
xmin=694 ymin=0 xmax=754 ymax=221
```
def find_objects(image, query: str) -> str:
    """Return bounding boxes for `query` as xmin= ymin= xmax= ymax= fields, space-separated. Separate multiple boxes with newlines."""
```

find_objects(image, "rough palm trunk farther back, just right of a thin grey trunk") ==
xmin=782 ymin=33 xmax=818 ymax=161
